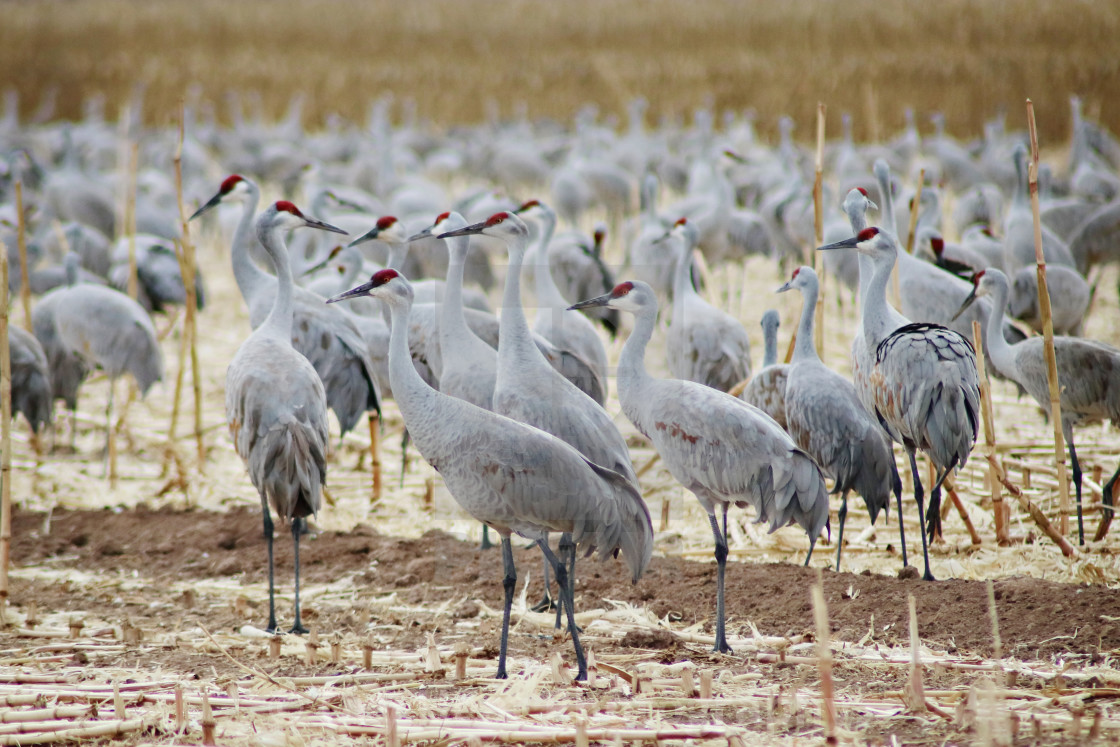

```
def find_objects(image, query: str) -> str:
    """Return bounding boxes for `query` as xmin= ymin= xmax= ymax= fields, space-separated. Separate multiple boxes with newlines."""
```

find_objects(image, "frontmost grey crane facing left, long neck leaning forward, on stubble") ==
xmin=330 ymin=268 xmax=653 ymax=680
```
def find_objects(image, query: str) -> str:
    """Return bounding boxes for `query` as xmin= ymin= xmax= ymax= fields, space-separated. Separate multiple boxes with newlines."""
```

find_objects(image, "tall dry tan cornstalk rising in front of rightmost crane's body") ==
xmin=1027 ymin=99 xmax=1066 ymax=544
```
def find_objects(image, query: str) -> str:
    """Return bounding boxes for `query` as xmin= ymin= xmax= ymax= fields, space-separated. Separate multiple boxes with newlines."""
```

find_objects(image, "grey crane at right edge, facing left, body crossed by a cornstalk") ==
xmin=961 ymin=270 xmax=1120 ymax=544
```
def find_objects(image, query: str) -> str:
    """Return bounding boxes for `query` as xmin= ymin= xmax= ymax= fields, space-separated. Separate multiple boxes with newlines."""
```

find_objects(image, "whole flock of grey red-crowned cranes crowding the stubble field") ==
xmin=0 ymin=90 xmax=1120 ymax=678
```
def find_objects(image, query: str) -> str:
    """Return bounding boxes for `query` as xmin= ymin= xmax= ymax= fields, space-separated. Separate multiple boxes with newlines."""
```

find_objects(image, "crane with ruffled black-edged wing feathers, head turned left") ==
xmin=819 ymin=226 xmax=980 ymax=580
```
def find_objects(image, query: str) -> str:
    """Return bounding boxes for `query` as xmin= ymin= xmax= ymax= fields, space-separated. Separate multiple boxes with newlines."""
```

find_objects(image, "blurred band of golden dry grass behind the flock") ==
xmin=0 ymin=0 xmax=1120 ymax=142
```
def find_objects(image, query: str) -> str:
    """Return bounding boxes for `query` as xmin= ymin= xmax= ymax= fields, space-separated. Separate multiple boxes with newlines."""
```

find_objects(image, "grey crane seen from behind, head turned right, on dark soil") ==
xmin=225 ymin=200 xmax=343 ymax=633
